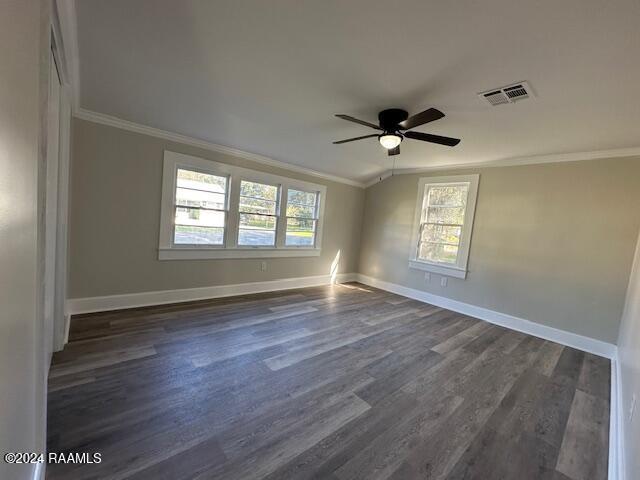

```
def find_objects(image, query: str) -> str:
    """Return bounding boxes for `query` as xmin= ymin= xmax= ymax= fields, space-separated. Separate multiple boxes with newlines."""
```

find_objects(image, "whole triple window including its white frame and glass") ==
xmin=158 ymin=151 xmax=326 ymax=260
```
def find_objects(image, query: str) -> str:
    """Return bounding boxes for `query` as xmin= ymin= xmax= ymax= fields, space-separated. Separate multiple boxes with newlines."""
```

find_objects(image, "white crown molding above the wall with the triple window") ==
xmin=74 ymin=108 xmax=365 ymax=188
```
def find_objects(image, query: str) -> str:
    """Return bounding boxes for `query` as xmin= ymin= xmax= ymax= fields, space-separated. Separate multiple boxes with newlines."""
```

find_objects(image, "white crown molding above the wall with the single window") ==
xmin=364 ymin=147 xmax=640 ymax=188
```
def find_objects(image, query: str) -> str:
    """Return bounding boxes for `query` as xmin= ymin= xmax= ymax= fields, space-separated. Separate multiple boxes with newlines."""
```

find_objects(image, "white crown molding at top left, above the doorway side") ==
xmin=53 ymin=0 xmax=80 ymax=111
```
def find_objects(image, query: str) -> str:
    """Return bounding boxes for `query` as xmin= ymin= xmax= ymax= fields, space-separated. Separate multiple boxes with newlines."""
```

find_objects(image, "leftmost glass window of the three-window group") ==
xmin=173 ymin=168 xmax=227 ymax=245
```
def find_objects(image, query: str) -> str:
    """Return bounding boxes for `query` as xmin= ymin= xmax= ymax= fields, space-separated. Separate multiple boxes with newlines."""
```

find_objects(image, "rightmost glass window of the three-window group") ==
xmin=285 ymin=188 xmax=318 ymax=247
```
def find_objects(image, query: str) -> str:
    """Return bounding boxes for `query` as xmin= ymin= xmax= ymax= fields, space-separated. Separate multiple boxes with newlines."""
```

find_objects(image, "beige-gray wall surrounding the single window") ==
xmin=360 ymin=158 xmax=640 ymax=343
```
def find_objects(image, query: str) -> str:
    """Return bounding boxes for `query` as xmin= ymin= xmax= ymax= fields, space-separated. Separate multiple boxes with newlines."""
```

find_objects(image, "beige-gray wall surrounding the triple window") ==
xmin=69 ymin=119 xmax=364 ymax=298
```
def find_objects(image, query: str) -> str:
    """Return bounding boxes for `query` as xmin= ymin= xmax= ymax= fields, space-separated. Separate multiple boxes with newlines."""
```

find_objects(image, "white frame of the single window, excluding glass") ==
xmin=409 ymin=174 xmax=480 ymax=279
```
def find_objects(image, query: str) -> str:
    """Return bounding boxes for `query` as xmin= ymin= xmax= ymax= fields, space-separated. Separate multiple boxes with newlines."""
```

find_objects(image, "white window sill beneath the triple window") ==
xmin=158 ymin=247 xmax=320 ymax=260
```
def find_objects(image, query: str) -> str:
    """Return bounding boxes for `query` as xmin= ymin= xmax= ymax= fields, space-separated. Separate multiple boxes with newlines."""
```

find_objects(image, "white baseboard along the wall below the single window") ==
xmin=358 ymin=274 xmax=616 ymax=358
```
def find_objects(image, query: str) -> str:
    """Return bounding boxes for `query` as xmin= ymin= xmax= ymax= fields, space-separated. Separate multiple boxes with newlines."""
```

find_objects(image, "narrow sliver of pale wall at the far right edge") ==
xmin=618 ymin=232 xmax=640 ymax=479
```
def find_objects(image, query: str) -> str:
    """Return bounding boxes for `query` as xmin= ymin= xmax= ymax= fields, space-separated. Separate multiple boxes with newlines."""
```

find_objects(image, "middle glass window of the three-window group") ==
xmin=238 ymin=180 xmax=280 ymax=246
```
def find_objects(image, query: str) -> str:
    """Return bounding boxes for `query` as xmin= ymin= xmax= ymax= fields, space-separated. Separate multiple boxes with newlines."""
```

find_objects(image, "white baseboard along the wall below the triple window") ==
xmin=67 ymin=273 xmax=357 ymax=315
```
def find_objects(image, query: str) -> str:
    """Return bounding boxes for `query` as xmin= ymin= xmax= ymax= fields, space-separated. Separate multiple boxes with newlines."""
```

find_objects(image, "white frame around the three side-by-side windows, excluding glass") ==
xmin=158 ymin=150 xmax=327 ymax=260
